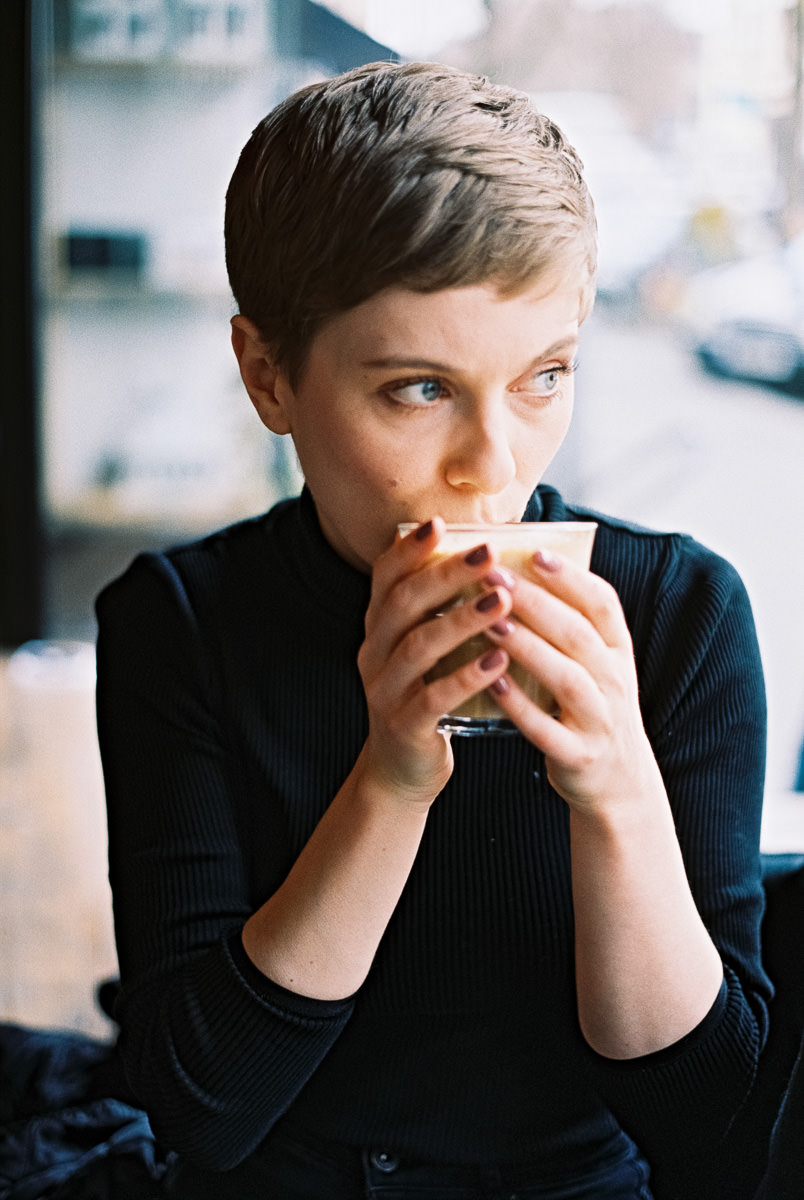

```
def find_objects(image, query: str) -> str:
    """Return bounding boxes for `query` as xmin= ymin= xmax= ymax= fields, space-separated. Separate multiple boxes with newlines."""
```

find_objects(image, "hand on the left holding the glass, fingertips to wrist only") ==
xmin=358 ymin=517 xmax=511 ymax=805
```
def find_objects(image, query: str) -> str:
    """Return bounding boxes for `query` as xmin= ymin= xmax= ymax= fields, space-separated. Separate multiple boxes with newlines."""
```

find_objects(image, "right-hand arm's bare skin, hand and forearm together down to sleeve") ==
xmin=486 ymin=554 xmax=722 ymax=1058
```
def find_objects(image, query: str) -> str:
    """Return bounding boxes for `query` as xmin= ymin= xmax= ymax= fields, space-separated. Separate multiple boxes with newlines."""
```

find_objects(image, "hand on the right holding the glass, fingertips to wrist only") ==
xmin=488 ymin=552 xmax=665 ymax=812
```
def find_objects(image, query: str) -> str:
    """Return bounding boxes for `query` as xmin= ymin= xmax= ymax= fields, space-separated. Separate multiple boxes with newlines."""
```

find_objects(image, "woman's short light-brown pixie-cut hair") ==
xmin=224 ymin=62 xmax=596 ymax=379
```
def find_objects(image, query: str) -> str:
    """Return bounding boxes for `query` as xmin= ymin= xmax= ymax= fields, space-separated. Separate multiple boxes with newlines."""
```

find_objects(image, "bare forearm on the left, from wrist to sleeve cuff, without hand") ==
xmin=242 ymin=751 xmax=428 ymax=1000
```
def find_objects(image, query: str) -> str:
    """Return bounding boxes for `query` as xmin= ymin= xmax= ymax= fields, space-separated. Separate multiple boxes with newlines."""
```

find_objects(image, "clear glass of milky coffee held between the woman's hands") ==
xmin=400 ymin=521 xmax=598 ymax=737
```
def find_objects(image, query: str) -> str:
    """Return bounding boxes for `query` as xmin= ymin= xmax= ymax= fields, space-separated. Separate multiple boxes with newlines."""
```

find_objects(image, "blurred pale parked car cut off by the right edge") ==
xmin=683 ymin=234 xmax=804 ymax=394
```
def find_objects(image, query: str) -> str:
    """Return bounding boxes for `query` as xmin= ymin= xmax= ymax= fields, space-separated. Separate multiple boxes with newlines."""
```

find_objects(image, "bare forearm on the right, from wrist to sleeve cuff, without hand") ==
xmin=570 ymin=794 xmax=722 ymax=1058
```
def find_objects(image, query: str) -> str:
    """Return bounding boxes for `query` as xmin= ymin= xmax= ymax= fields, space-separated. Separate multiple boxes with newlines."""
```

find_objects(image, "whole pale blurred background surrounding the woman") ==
xmin=0 ymin=0 xmax=804 ymax=1030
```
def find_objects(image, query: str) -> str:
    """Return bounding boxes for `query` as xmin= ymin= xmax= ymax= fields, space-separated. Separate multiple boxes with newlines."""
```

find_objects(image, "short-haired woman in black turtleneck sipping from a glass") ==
xmin=98 ymin=64 xmax=768 ymax=1200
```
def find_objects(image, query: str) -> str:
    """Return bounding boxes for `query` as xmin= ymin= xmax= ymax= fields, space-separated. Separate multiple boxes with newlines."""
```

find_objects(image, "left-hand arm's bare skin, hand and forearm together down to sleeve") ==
xmin=242 ymin=521 xmax=511 ymax=1000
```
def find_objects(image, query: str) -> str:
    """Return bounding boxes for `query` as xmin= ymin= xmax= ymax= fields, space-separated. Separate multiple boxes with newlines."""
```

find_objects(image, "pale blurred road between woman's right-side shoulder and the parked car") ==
xmin=552 ymin=304 xmax=804 ymax=806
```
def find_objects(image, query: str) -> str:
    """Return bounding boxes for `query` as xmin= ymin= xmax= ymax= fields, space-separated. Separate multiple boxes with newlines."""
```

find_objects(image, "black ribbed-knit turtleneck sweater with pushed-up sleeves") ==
xmin=97 ymin=487 xmax=769 ymax=1196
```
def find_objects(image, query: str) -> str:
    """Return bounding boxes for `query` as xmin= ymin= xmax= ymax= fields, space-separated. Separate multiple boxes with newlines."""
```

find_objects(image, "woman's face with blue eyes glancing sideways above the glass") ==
xmin=266 ymin=280 xmax=581 ymax=570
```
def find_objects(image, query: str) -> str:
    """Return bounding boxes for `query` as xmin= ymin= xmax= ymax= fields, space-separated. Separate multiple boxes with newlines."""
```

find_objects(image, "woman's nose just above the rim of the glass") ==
xmin=445 ymin=402 xmax=516 ymax=496
